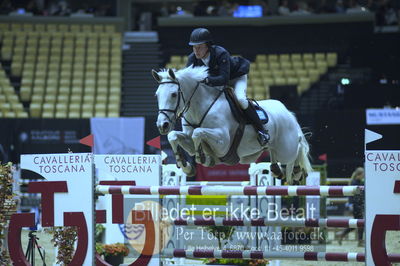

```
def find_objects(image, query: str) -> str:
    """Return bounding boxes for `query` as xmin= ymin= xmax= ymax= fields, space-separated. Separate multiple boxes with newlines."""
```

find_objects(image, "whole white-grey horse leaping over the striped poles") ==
xmin=152 ymin=66 xmax=312 ymax=184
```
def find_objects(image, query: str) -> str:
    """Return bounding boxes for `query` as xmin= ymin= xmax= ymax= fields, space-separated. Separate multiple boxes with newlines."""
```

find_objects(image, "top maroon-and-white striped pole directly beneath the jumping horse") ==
xmin=96 ymin=185 xmax=364 ymax=196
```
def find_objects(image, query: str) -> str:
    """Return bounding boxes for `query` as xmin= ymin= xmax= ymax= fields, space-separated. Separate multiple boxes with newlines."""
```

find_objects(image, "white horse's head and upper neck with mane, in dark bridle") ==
xmin=152 ymin=66 xmax=208 ymax=135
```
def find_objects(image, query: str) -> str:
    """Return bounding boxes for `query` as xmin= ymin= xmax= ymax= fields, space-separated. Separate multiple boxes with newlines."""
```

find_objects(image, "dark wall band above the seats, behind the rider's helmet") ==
xmin=158 ymin=17 xmax=373 ymax=59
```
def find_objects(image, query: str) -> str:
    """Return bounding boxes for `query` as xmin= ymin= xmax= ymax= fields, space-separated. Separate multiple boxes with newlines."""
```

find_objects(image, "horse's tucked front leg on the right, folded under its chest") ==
xmin=192 ymin=128 xmax=229 ymax=166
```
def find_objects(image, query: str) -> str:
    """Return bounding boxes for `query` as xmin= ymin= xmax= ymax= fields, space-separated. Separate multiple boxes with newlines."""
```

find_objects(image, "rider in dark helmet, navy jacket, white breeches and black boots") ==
xmin=186 ymin=28 xmax=269 ymax=146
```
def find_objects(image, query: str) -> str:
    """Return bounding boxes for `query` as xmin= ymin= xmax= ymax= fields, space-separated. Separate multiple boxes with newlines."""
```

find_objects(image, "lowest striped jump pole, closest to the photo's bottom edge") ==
xmin=163 ymin=249 xmax=400 ymax=262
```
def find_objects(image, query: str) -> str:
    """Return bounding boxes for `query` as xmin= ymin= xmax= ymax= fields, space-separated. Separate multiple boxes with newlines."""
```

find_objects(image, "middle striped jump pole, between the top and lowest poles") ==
xmin=172 ymin=217 xmax=364 ymax=228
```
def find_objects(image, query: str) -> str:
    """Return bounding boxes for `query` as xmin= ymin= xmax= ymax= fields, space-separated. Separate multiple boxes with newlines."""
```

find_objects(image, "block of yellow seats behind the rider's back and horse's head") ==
xmin=166 ymin=53 xmax=337 ymax=100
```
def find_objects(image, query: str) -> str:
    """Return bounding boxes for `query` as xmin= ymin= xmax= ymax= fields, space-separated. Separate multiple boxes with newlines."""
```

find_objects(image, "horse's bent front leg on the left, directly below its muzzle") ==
xmin=168 ymin=131 xmax=196 ymax=176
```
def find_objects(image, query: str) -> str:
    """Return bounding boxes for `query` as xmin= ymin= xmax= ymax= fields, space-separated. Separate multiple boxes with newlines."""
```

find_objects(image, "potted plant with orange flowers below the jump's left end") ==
xmin=96 ymin=243 xmax=129 ymax=266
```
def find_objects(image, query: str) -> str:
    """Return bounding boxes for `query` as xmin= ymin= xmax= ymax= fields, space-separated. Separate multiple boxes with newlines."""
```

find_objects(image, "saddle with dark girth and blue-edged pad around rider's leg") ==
xmin=219 ymin=87 xmax=268 ymax=165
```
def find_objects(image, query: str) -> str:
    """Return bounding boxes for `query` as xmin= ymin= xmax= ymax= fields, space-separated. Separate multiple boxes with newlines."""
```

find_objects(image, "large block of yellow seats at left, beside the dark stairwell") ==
xmin=0 ymin=23 xmax=121 ymax=118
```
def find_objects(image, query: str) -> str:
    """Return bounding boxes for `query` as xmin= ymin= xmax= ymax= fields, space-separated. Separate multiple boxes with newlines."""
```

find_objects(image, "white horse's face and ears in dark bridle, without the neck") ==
xmin=151 ymin=69 xmax=182 ymax=135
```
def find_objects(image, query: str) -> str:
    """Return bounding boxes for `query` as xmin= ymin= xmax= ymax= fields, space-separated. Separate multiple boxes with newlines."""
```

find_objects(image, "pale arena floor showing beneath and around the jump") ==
xmin=21 ymin=230 xmax=400 ymax=266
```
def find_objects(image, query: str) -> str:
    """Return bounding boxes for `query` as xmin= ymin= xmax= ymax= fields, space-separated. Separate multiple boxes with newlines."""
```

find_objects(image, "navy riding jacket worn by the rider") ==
xmin=186 ymin=45 xmax=250 ymax=86
